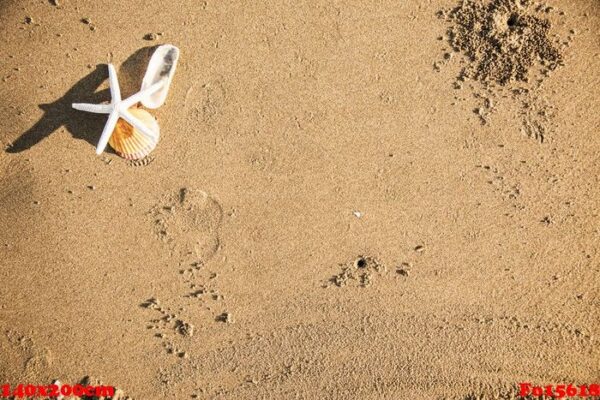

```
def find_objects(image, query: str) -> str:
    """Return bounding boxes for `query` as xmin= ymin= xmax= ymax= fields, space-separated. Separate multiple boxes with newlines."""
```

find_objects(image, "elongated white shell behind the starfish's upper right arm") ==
xmin=142 ymin=44 xmax=179 ymax=109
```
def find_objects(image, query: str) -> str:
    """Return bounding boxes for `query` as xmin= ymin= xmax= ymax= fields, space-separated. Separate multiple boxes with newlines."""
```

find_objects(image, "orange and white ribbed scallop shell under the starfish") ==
xmin=108 ymin=108 xmax=160 ymax=160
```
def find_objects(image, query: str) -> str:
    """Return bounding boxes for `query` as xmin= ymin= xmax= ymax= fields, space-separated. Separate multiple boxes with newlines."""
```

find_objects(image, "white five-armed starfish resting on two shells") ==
xmin=73 ymin=64 xmax=165 ymax=154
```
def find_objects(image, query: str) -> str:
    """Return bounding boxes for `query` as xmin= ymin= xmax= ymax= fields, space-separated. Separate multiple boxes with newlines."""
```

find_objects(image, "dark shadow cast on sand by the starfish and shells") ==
xmin=5 ymin=46 xmax=155 ymax=153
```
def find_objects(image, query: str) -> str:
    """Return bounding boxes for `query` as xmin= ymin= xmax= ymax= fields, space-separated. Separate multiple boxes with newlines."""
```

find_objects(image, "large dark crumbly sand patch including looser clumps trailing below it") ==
xmin=434 ymin=0 xmax=576 ymax=143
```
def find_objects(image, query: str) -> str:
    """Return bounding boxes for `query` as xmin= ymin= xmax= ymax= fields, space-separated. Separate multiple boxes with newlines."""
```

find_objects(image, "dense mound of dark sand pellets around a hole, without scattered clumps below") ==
xmin=448 ymin=0 xmax=562 ymax=85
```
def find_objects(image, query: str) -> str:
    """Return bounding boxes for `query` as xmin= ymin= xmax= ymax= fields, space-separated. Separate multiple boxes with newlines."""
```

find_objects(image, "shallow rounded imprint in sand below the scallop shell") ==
xmin=151 ymin=188 xmax=223 ymax=263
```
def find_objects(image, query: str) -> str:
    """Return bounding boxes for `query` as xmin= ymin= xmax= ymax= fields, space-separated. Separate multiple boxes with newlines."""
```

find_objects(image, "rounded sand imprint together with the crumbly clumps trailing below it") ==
xmin=141 ymin=188 xmax=223 ymax=358
